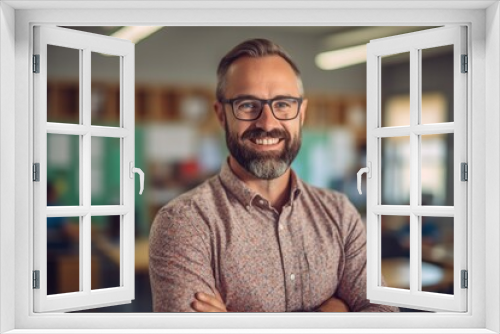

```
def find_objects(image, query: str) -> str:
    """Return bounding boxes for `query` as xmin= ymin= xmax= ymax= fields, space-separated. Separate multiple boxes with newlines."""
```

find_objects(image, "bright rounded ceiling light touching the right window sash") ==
xmin=315 ymin=44 xmax=366 ymax=70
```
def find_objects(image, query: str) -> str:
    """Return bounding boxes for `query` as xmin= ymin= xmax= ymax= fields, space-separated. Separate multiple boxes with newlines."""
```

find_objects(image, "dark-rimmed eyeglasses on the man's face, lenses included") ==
xmin=220 ymin=97 xmax=302 ymax=121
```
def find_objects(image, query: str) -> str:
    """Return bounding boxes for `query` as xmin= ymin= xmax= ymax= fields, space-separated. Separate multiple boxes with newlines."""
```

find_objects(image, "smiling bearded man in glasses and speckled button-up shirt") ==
xmin=150 ymin=39 xmax=398 ymax=312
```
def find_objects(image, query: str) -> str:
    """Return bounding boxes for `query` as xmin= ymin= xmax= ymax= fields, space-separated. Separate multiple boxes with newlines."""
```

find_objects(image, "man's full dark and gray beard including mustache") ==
xmin=224 ymin=121 xmax=302 ymax=180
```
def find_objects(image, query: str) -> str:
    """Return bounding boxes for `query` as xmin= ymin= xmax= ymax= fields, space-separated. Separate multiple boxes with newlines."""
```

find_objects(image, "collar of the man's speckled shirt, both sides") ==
xmin=219 ymin=158 xmax=303 ymax=206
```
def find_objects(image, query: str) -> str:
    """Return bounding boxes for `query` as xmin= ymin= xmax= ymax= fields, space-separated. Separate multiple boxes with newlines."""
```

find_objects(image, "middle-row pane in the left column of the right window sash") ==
xmin=380 ymin=137 xmax=410 ymax=205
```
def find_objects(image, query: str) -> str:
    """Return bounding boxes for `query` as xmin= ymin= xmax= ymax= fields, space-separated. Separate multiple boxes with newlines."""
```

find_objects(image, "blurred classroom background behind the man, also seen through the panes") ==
xmin=47 ymin=27 xmax=453 ymax=312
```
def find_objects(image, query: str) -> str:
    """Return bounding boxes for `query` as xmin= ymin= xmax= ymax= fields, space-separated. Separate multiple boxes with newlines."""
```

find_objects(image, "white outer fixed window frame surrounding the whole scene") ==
xmin=0 ymin=0 xmax=500 ymax=333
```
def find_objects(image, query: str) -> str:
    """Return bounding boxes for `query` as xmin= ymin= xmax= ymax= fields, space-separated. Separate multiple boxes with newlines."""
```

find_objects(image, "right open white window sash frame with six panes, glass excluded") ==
xmin=366 ymin=25 xmax=470 ymax=312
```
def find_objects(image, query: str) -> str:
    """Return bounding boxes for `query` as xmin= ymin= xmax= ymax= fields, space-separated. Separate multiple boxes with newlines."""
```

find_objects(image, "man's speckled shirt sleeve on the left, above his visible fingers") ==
xmin=149 ymin=201 xmax=215 ymax=312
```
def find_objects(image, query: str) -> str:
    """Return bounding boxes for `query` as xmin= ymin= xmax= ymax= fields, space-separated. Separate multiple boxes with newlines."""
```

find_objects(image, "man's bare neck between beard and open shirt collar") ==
xmin=229 ymin=156 xmax=292 ymax=212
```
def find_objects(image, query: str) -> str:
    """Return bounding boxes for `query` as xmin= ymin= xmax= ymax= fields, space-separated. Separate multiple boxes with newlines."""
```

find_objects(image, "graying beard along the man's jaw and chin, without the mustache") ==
xmin=225 ymin=123 xmax=302 ymax=180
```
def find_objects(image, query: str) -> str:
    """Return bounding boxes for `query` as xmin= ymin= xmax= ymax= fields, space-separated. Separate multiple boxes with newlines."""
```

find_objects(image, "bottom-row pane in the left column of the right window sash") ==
xmin=380 ymin=216 xmax=410 ymax=289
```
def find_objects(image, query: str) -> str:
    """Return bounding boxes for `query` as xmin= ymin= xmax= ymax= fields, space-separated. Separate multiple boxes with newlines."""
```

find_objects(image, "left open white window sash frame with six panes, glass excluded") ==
xmin=33 ymin=25 xmax=135 ymax=312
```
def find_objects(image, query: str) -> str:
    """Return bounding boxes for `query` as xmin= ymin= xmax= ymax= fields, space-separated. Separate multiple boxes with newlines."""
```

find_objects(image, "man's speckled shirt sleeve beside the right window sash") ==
xmin=336 ymin=196 xmax=399 ymax=312
